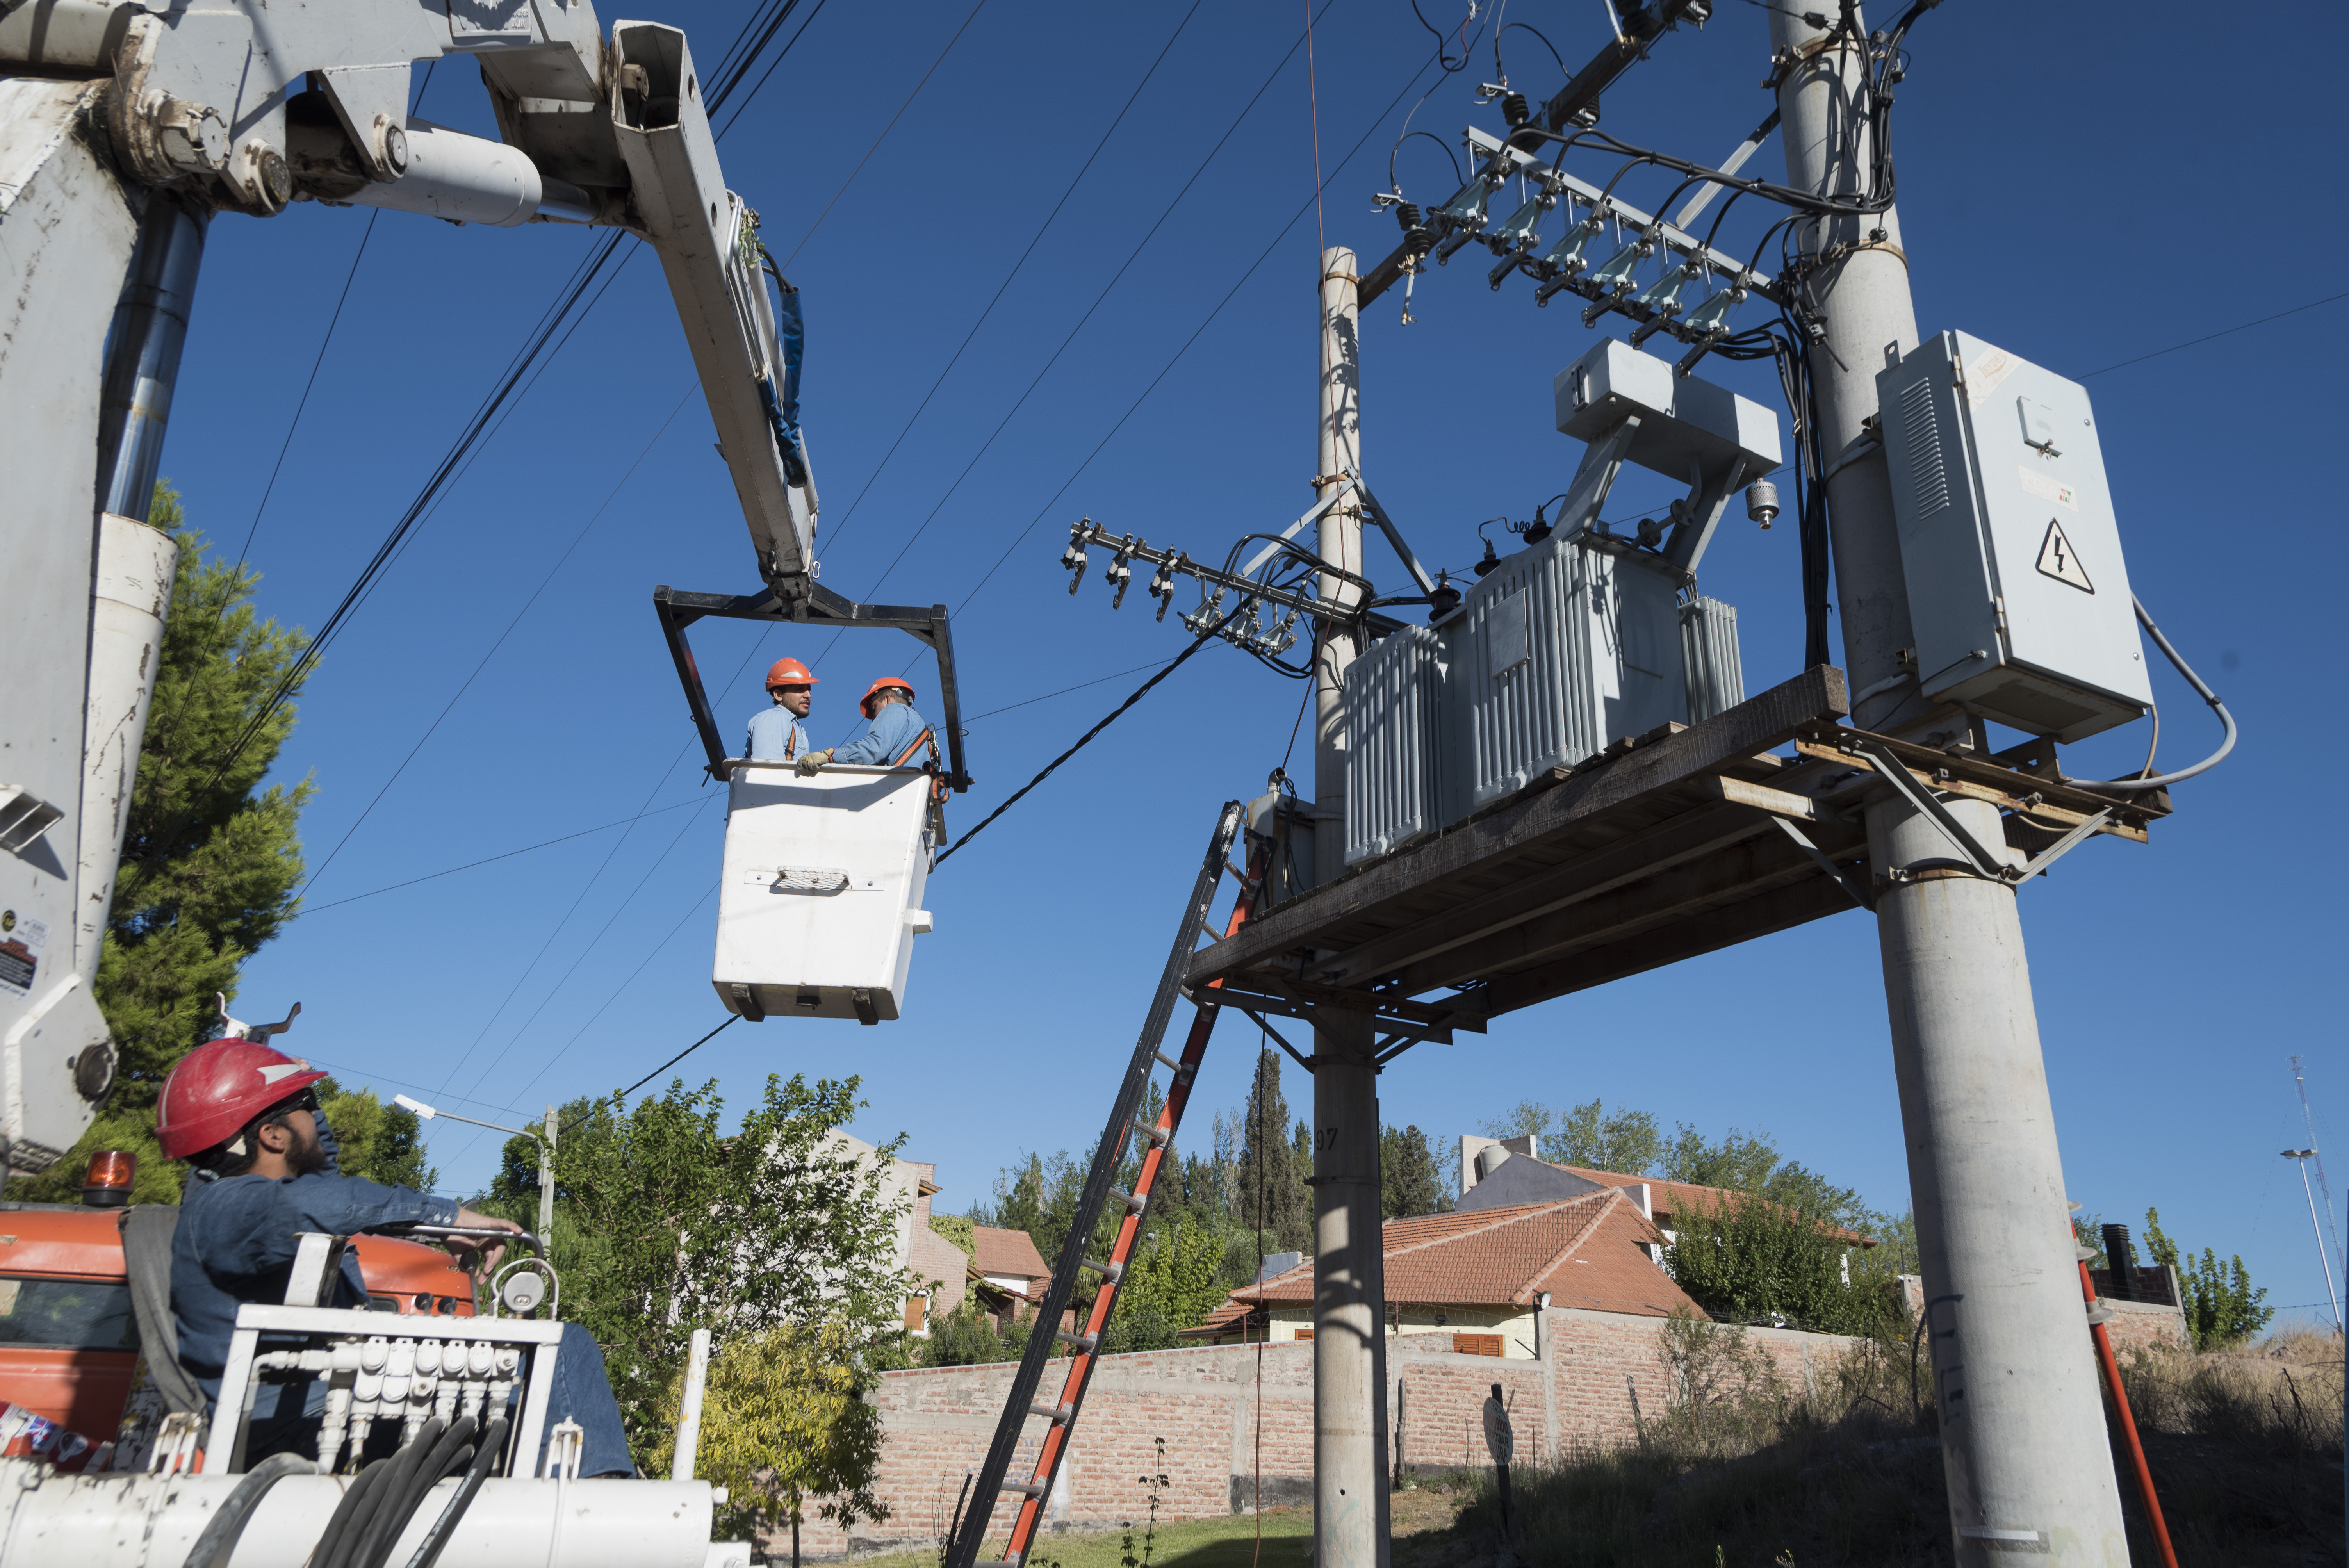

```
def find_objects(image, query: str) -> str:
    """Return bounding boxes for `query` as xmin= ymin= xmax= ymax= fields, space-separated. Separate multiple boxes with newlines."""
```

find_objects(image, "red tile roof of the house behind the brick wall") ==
xmin=1226 ymin=1190 xmax=1703 ymax=1317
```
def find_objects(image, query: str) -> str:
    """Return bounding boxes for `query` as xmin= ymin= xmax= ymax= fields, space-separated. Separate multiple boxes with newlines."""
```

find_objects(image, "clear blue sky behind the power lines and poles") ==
xmin=151 ymin=0 xmax=2349 ymax=1317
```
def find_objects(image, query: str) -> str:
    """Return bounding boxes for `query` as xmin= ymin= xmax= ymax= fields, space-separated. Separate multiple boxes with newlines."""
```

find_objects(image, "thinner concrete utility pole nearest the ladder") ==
xmin=1313 ymin=246 xmax=1388 ymax=1568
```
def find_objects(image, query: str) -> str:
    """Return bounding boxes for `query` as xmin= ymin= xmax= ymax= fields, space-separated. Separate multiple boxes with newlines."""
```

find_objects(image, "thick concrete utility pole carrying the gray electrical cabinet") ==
xmin=1769 ymin=9 xmax=2128 ymax=1568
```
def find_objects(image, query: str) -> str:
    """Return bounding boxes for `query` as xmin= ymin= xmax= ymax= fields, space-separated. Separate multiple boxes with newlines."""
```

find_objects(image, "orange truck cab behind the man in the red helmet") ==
xmin=0 ymin=1202 xmax=472 ymax=1458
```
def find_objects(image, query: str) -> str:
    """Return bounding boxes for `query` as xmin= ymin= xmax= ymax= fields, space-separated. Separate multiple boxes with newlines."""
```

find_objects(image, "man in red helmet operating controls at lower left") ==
xmin=155 ymin=1040 xmax=634 ymax=1477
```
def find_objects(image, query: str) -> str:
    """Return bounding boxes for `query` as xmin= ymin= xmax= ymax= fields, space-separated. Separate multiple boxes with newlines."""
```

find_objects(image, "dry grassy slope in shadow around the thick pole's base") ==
xmin=1395 ymin=1322 xmax=2342 ymax=1568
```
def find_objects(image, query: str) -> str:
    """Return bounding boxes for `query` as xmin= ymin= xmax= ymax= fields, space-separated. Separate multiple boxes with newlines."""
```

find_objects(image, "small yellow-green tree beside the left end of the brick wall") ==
xmin=648 ymin=1314 xmax=888 ymax=1568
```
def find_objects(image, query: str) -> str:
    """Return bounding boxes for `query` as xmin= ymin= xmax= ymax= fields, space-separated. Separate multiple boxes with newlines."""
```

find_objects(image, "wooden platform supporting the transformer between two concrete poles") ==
xmin=1189 ymin=666 xmax=2168 ymax=1040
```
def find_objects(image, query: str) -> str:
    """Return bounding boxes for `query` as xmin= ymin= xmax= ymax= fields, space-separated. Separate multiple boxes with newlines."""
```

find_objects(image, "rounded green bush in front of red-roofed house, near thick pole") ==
xmin=1663 ymin=1192 xmax=1893 ymax=1333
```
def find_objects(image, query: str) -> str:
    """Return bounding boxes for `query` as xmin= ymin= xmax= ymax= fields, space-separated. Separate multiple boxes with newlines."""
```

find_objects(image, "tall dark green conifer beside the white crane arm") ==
xmin=12 ymin=483 xmax=310 ymax=1204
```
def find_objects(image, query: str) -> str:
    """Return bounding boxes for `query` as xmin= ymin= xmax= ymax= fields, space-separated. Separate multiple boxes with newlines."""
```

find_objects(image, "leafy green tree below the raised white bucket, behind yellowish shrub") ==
xmin=549 ymin=1075 xmax=911 ymax=1458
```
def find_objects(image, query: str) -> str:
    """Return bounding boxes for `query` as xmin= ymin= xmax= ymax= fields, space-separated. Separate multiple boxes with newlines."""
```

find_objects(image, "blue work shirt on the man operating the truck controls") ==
xmin=171 ymin=1171 xmax=458 ymax=1415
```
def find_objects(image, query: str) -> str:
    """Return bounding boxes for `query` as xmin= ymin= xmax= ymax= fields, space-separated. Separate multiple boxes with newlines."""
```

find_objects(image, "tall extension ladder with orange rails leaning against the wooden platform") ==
xmin=946 ymin=800 xmax=1264 ymax=1568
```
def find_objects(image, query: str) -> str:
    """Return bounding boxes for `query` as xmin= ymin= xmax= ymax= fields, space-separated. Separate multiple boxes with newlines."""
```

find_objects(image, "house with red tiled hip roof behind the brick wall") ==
xmin=1184 ymin=1183 xmax=1706 ymax=1359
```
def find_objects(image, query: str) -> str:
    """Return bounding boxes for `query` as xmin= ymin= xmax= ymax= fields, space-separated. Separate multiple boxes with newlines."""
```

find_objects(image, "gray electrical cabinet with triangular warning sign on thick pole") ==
xmin=1877 ymin=331 xmax=2154 ymax=742
